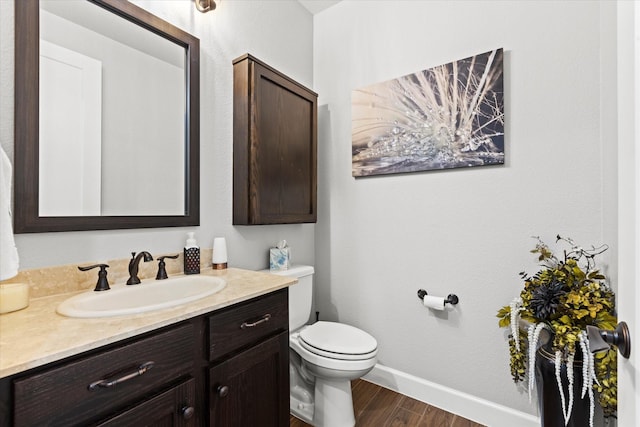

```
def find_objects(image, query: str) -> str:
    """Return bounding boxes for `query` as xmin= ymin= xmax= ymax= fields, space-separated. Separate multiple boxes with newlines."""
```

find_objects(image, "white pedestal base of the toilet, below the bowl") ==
xmin=311 ymin=378 xmax=356 ymax=427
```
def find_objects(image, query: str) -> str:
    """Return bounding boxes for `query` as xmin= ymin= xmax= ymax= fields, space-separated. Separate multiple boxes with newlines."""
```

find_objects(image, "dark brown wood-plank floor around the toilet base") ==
xmin=289 ymin=380 xmax=483 ymax=427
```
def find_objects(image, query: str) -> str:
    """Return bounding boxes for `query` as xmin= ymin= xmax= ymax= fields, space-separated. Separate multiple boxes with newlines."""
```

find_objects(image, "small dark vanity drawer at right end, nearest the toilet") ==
xmin=209 ymin=288 xmax=289 ymax=360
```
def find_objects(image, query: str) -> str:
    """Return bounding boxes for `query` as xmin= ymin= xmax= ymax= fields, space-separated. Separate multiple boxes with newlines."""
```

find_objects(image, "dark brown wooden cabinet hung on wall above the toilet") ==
xmin=233 ymin=54 xmax=318 ymax=225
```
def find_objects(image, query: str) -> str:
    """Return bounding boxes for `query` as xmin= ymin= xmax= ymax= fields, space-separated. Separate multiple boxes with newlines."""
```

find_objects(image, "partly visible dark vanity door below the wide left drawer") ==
xmin=98 ymin=378 xmax=200 ymax=427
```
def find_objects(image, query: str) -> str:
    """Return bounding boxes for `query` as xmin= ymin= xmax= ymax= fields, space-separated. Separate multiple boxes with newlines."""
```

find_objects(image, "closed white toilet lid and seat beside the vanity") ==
xmin=300 ymin=322 xmax=378 ymax=360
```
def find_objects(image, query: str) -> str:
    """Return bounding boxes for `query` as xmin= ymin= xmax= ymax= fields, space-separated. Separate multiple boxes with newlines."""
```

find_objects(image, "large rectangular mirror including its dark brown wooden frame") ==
xmin=14 ymin=0 xmax=200 ymax=233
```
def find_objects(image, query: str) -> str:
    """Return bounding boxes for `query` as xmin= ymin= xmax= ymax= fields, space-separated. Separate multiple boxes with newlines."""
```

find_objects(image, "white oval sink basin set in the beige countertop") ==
xmin=56 ymin=275 xmax=227 ymax=317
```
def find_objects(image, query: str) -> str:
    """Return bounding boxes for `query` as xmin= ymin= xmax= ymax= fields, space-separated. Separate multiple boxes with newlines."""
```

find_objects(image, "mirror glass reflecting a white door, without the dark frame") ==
xmin=39 ymin=0 xmax=186 ymax=216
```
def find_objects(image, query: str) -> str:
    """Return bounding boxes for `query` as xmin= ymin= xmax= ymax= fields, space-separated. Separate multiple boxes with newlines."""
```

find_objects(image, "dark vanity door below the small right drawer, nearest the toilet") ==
xmin=209 ymin=332 xmax=289 ymax=427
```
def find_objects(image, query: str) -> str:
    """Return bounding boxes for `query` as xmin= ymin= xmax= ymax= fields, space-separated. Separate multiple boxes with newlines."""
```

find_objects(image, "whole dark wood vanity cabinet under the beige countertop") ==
xmin=0 ymin=289 xmax=289 ymax=427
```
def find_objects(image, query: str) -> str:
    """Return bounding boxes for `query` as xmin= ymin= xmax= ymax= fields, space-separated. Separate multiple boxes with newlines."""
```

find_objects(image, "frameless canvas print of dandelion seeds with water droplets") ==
xmin=351 ymin=49 xmax=504 ymax=177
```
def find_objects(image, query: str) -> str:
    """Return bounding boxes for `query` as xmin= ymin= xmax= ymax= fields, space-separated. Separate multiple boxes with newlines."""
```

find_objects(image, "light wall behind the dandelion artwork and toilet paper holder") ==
xmin=314 ymin=0 xmax=616 ymax=425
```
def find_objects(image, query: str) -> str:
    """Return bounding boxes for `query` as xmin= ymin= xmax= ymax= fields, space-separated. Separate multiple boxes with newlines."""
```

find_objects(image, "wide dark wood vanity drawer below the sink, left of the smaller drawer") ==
xmin=13 ymin=323 xmax=194 ymax=426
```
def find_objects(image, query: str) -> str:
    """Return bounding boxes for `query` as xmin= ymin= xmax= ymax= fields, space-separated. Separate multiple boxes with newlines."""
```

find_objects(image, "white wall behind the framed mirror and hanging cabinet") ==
xmin=0 ymin=0 xmax=314 ymax=269
